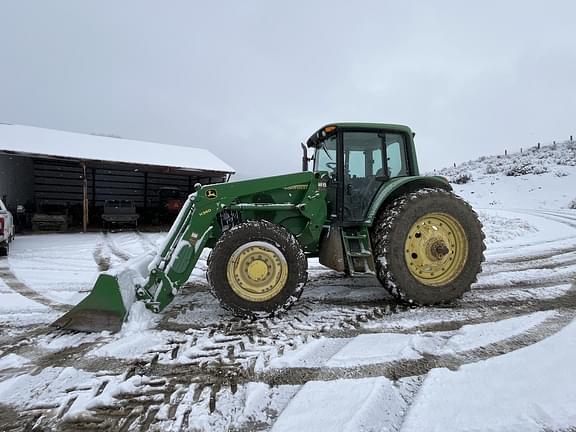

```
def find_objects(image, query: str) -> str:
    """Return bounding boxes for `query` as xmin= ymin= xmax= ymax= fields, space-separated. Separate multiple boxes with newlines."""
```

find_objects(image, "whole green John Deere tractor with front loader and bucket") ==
xmin=54 ymin=123 xmax=485 ymax=331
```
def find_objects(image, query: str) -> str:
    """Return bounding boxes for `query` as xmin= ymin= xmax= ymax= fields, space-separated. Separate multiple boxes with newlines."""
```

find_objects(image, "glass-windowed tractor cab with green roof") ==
xmin=307 ymin=123 xmax=418 ymax=226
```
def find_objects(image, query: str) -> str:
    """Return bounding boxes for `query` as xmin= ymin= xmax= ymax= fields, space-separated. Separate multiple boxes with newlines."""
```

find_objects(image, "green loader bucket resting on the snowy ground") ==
xmin=51 ymin=273 xmax=130 ymax=332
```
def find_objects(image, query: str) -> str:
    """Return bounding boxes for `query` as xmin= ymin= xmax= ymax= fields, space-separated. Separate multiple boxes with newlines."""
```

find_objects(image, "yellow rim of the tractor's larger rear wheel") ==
xmin=404 ymin=213 xmax=468 ymax=286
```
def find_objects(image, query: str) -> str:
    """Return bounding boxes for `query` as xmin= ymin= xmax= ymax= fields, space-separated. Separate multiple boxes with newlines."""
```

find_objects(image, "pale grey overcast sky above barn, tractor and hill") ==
xmin=0 ymin=0 xmax=576 ymax=177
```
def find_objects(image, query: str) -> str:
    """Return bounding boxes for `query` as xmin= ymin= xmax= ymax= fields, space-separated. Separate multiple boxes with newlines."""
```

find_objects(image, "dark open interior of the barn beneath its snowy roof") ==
xmin=0 ymin=151 xmax=228 ymax=230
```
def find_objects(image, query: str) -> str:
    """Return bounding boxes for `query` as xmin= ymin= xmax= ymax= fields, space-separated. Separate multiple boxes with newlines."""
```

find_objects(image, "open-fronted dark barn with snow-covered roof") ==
xmin=0 ymin=123 xmax=234 ymax=231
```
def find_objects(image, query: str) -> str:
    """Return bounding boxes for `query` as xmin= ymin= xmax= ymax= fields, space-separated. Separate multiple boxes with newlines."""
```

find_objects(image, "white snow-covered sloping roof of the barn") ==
xmin=0 ymin=123 xmax=235 ymax=173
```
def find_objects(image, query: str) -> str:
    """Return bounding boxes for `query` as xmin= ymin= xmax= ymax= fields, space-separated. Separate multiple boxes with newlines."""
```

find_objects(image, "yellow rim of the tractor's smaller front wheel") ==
xmin=226 ymin=242 xmax=288 ymax=302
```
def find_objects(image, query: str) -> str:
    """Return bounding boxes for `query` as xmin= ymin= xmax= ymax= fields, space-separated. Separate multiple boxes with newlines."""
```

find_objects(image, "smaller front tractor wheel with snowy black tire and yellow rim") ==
xmin=206 ymin=220 xmax=308 ymax=318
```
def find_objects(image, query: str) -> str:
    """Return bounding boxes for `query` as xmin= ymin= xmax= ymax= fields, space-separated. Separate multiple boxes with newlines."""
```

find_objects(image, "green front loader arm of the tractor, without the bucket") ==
xmin=136 ymin=172 xmax=326 ymax=312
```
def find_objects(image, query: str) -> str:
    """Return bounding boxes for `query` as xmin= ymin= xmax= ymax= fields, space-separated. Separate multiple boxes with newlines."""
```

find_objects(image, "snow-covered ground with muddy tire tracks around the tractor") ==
xmin=0 ymin=141 xmax=576 ymax=432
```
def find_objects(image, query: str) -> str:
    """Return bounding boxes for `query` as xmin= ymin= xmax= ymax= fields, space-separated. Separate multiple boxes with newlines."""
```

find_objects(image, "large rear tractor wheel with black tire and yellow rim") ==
xmin=372 ymin=189 xmax=486 ymax=305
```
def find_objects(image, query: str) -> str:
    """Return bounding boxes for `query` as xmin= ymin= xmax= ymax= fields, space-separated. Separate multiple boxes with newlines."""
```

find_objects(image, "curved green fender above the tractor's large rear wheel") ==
xmin=366 ymin=176 xmax=452 ymax=226
